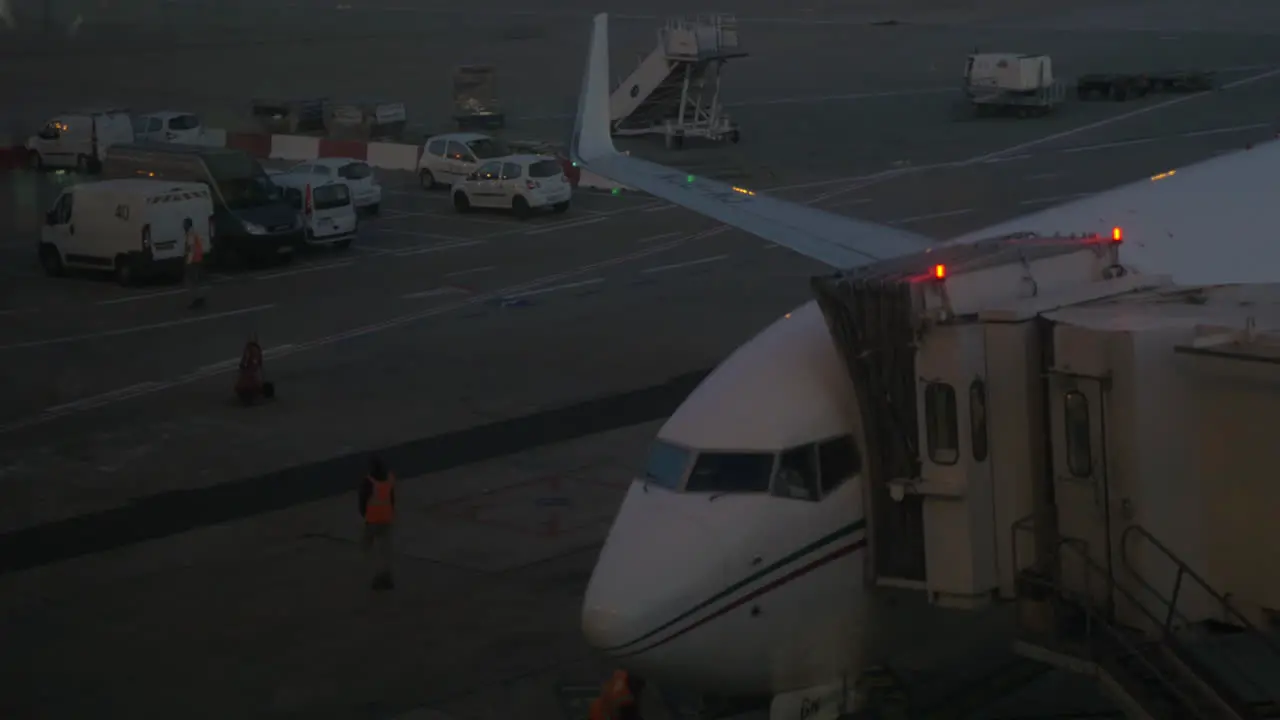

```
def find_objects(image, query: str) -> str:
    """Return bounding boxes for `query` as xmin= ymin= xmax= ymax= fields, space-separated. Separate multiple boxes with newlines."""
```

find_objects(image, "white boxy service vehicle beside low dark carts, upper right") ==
xmin=964 ymin=53 xmax=1066 ymax=118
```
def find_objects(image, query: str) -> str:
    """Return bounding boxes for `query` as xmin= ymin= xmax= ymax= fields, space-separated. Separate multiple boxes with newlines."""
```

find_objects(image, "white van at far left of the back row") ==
xmin=27 ymin=110 xmax=133 ymax=173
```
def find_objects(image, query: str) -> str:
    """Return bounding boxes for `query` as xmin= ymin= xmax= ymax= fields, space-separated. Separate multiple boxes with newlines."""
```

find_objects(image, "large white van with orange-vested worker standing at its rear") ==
xmin=40 ymin=179 xmax=216 ymax=284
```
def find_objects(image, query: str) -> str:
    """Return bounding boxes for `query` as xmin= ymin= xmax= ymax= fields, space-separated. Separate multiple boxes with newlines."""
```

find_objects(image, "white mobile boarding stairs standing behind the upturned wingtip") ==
xmin=609 ymin=15 xmax=746 ymax=147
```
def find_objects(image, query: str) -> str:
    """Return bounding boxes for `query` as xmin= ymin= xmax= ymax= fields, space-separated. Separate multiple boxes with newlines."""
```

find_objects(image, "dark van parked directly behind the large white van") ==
xmin=102 ymin=142 xmax=305 ymax=265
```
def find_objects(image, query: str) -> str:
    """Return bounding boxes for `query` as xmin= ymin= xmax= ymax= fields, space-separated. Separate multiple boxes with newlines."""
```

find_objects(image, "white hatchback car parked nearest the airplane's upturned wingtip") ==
xmin=451 ymin=155 xmax=573 ymax=218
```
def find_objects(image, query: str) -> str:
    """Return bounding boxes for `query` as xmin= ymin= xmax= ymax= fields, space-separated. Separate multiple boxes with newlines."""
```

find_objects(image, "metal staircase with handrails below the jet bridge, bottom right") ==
xmin=1014 ymin=518 xmax=1280 ymax=720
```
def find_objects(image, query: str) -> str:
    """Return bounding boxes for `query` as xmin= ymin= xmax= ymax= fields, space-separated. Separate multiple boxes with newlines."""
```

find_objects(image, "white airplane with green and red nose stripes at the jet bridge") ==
xmin=571 ymin=14 xmax=1280 ymax=717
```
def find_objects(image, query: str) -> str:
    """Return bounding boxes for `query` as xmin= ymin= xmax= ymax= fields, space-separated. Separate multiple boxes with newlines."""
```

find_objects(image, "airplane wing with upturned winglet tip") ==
xmin=570 ymin=13 xmax=934 ymax=269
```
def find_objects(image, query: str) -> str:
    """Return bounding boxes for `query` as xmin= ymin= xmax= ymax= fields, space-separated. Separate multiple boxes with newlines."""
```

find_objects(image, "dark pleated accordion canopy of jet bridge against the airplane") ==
xmin=810 ymin=273 xmax=925 ymax=582
